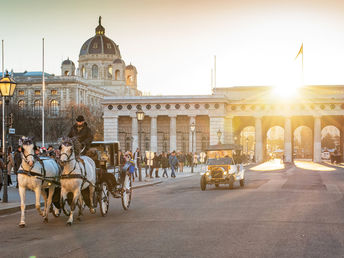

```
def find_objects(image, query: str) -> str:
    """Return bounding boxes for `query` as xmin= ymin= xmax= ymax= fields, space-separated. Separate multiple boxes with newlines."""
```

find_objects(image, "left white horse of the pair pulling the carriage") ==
xmin=18 ymin=138 xmax=60 ymax=227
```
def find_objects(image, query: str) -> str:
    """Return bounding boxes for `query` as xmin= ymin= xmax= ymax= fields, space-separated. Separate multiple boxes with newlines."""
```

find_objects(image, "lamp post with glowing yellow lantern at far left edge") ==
xmin=0 ymin=71 xmax=17 ymax=202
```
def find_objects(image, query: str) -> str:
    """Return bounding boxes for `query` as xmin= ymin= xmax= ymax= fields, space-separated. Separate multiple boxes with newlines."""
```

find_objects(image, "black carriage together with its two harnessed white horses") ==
xmin=19 ymin=138 xmax=132 ymax=226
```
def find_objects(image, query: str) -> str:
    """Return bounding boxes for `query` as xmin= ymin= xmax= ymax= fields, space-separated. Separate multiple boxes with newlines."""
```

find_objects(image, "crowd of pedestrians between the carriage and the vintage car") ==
xmin=120 ymin=148 xmax=204 ymax=180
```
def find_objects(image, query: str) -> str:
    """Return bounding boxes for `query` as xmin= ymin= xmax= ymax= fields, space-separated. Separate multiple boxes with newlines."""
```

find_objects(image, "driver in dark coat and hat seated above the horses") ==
xmin=68 ymin=115 xmax=93 ymax=155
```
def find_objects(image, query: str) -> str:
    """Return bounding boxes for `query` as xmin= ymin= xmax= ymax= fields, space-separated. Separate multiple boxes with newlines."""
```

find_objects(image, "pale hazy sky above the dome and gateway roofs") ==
xmin=0 ymin=0 xmax=344 ymax=95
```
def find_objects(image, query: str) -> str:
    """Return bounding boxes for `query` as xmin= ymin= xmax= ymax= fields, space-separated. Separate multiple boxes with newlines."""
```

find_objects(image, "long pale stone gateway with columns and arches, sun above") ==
xmin=102 ymin=86 xmax=344 ymax=162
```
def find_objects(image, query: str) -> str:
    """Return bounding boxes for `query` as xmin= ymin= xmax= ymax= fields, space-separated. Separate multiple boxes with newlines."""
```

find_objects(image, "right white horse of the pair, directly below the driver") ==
xmin=60 ymin=138 xmax=96 ymax=225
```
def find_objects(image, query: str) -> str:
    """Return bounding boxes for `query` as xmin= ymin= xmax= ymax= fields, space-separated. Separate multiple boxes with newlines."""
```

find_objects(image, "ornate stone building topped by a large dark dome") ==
xmin=11 ymin=17 xmax=141 ymax=116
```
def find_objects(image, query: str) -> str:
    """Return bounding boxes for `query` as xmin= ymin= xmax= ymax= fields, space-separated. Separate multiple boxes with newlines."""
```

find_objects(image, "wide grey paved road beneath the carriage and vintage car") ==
xmin=0 ymin=164 xmax=344 ymax=257
